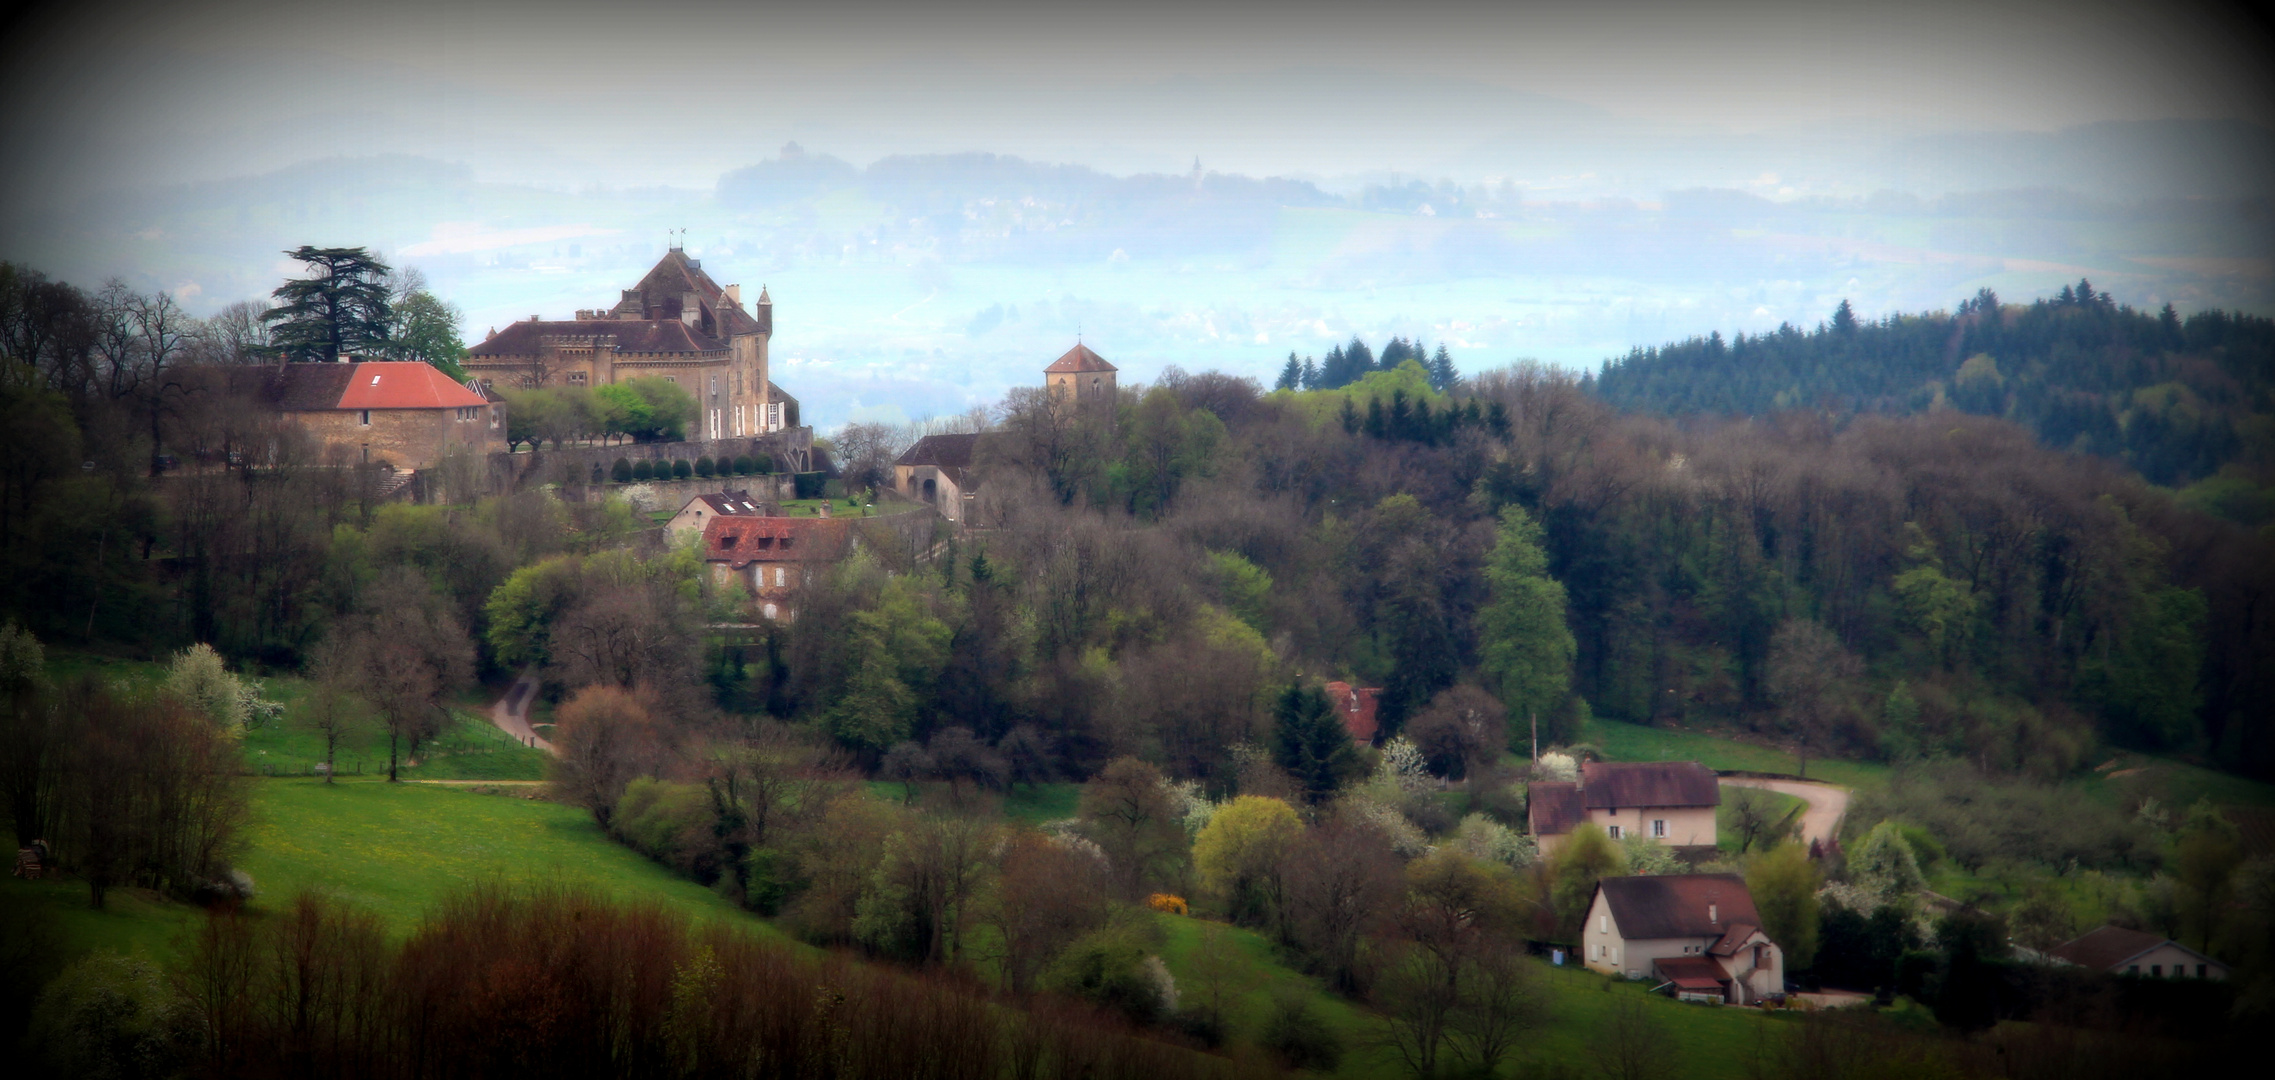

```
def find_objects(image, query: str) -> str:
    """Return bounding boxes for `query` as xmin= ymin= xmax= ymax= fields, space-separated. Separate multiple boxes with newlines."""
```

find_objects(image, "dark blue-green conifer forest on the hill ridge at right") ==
xmin=1588 ymin=280 xmax=2275 ymax=491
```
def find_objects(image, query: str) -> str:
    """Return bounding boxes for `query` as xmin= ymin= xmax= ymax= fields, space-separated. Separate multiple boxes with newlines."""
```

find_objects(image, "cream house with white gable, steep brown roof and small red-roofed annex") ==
xmin=1581 ymin=873 xmax=1786 ymax=1005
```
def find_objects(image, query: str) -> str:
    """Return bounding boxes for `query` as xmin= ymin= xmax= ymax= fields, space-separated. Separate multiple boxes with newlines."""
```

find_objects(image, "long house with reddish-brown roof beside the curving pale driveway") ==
xmin=1529 ymin=762 xmax=1722 ymax=855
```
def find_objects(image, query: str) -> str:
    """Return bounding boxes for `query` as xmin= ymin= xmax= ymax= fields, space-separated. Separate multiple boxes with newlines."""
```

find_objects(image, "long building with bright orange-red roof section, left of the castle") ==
xmin=214 ymin=362 xmax=505 ymax=471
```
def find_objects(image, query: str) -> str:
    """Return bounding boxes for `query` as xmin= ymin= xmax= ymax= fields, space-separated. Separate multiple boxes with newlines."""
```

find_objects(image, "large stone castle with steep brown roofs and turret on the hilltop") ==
xmin=464 ymin=248 xmax=796 ymax=439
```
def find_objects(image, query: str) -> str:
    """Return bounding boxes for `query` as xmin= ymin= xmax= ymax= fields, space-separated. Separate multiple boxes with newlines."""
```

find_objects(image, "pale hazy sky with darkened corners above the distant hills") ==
xmin=0 ymin=0 xmax=2270 ymax=198
